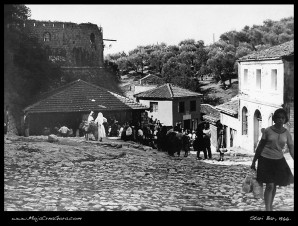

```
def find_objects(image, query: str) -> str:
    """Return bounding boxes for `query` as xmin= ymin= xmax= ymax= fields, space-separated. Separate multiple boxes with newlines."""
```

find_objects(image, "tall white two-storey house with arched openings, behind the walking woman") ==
xmin=235 ymin=41 xmax=294 ymax=152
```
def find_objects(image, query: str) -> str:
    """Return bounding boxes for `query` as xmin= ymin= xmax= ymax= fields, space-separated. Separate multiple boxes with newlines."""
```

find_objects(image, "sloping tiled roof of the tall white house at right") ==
xmin=238 ymin=40 xmax=294 ymax=61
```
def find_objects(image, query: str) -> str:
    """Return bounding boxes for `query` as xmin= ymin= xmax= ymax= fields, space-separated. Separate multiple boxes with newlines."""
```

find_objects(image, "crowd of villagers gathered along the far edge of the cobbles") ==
xmin=42 ymin=111 xmax=226 ymax=161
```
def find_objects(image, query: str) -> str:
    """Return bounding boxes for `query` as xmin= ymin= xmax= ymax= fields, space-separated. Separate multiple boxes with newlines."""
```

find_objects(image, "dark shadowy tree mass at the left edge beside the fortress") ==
xmin=4 ymin=5 xmax=61 ymax=110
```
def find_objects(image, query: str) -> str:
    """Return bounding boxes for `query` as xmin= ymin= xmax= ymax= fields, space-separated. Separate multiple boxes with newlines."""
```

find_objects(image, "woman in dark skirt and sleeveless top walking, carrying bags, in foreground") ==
xmin=251 ymin=108 xmax=294 ymax=211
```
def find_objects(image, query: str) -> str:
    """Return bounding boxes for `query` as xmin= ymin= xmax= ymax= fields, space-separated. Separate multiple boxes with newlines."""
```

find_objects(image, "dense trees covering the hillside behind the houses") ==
xmin=106 ymin=17 xmax=294 ymax=91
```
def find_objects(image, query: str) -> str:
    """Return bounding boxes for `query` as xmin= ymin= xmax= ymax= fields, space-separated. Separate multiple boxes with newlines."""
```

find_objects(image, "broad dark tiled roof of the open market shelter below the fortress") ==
xmin=24 ymin=79 xmax=148 ymax=113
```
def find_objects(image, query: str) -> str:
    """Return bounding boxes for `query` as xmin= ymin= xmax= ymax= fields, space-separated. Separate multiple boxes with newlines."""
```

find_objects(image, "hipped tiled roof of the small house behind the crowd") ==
xmin=134 ymin=83 xmax=202 ymax=99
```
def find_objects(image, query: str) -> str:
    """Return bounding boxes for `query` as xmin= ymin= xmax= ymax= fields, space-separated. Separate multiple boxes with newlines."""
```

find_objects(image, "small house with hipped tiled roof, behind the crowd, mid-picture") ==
xmin=134 ymin=83 xmax=202 ymax=130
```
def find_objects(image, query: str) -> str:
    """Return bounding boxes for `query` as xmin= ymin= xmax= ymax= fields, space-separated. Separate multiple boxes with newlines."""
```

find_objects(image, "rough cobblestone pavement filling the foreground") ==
xmin=4 ymin=136 xmax=294 ymax=211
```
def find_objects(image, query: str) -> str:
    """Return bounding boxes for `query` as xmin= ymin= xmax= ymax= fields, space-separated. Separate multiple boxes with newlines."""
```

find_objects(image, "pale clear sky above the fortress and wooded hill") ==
xmin=26 ymin=4 xmax=294 ymax=55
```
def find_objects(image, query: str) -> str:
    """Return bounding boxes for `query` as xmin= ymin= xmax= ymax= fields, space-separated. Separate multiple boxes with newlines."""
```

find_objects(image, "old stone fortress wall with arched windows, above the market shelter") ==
xmin=22 ymin=20 xmax=104 ymax=67
